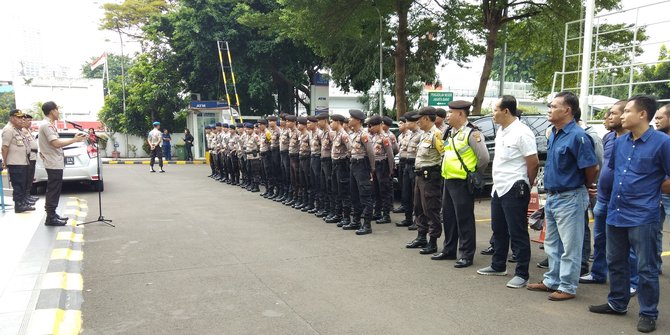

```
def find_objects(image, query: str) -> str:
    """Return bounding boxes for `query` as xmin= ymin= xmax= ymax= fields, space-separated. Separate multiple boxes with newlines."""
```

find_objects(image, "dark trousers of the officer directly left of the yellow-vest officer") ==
xmin=414 ymin=167 xmax=442 ymax=238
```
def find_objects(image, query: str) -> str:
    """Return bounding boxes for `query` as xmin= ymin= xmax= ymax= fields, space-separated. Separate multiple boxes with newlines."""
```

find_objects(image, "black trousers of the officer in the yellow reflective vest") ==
xmin=442 ymin=179 xmax=478 ymax=260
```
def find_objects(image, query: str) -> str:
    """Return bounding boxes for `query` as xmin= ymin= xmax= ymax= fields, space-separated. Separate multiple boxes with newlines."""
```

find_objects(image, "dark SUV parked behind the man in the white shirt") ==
xmin=469 ymin=114 xmax=551 ymax=185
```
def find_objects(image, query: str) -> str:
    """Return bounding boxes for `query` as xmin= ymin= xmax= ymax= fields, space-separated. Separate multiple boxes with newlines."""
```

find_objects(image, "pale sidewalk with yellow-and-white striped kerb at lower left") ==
xmin=0 ymin=197 xmax=86 ymax=335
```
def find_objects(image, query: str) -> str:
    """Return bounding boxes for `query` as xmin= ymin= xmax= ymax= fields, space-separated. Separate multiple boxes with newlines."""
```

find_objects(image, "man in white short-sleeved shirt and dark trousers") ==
xmin=477 ymin=95 xmax=539 ymax=288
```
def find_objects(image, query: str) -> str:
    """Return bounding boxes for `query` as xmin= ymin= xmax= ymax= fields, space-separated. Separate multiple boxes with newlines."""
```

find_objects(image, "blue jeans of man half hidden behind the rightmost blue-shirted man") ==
xmin=591 ymin=201 xmax=638 ymax=289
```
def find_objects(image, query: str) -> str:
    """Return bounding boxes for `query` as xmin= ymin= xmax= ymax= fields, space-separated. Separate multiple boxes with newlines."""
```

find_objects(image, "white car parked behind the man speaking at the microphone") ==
xmin=31 ymin=131 xmax=105 ymax=194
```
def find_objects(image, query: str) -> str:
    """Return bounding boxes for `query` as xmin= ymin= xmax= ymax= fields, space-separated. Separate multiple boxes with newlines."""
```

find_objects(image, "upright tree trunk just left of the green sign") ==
xmin=393 ymin=0 xmax=410 ymax=118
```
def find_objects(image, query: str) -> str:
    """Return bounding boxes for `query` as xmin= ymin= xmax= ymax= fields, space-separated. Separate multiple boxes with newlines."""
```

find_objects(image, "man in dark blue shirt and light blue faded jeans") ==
xmin=527 ymin=92 xmax=598 ymax=301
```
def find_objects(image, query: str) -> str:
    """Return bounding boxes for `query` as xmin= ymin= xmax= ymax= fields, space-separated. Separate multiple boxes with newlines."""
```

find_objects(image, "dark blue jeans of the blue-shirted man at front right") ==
xmin=607 ymin=222 xmax=659 ymax=319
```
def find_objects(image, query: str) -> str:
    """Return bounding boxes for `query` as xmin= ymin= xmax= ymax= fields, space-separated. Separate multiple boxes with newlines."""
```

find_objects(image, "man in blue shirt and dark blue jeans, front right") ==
xmin=589 ymin=96 xmax=670 ymax=333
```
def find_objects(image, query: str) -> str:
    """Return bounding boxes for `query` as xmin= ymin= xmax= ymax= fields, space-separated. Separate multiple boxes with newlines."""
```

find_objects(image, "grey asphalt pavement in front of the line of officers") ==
xmin=78 ymin=165 xmax=670 ymax=335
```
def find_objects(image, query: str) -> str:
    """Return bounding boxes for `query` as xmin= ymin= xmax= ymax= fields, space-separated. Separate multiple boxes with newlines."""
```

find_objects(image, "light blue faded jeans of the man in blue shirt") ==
xmin=543 ymin=187 xmax=589 ymax=294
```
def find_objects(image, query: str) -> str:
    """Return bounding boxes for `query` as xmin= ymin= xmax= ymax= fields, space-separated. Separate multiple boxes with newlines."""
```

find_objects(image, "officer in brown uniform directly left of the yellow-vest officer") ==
xmin=405 ymin=107 xmax=446 ymax=255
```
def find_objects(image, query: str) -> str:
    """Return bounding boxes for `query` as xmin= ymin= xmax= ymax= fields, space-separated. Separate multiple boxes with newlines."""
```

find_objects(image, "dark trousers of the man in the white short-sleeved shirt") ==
xmin=491 ymin=180 xmax=530 ymax=280
